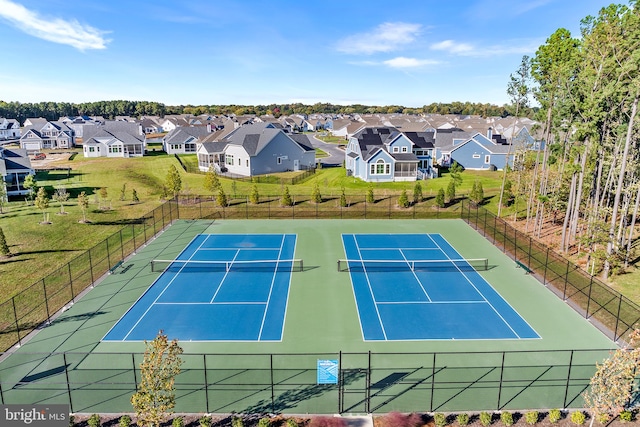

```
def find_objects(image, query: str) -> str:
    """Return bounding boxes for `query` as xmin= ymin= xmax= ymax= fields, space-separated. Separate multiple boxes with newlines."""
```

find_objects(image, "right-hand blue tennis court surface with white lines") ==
xmin=342 ymin=234 xmax=540 ymax=341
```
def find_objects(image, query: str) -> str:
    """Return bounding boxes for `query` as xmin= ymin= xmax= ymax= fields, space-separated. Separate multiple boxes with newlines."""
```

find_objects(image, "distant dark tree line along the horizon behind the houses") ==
xmin=0 ymin=100 xmax=536 ymax=123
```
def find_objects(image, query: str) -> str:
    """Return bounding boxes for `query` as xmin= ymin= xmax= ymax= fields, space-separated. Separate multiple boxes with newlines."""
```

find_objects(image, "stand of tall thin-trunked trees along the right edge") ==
xmin=501 ymin=0 xmax=640 ymax=279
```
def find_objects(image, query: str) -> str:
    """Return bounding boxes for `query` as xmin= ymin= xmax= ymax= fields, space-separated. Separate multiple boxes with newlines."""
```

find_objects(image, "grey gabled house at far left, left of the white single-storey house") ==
xmin=20 ymin=118 xmax=75 ymax=152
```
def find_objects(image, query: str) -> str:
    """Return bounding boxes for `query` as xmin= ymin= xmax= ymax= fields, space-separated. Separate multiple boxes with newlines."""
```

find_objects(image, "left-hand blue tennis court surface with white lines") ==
xmin=103 ymin=234 xmax=296 ymax=341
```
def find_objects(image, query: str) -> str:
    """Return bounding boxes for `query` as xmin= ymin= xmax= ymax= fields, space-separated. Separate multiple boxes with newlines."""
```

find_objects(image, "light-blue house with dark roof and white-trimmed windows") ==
xmin=345 ymin=126 xmax=435 ymax=182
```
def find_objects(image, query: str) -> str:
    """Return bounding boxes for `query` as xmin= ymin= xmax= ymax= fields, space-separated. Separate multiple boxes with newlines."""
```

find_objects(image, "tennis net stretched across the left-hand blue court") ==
xmin=151 ymin=259 xmax=303 ymax=273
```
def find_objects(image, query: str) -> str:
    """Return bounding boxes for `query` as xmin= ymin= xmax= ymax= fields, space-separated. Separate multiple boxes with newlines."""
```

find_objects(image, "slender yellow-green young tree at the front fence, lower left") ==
xmin=131 ymin=331 xmax=182 ymax=427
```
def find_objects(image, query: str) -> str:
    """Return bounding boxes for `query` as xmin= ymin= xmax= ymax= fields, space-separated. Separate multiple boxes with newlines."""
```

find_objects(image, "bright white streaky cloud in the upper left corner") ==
xmin=0 ymin=0 xmax=108 ymax=51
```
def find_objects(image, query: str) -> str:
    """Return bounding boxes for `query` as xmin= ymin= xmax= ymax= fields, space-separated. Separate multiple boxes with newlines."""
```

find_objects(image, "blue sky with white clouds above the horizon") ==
xmin=0 ymin=0 xmax=608 ymax=107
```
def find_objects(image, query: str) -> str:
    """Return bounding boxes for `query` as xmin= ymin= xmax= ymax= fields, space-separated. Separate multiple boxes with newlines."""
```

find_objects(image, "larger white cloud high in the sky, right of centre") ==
xmin=336 ymin=22 xmax=422 ymax=55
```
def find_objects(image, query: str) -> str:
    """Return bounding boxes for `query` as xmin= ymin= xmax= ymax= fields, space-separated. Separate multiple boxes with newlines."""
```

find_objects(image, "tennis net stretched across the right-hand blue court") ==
xmin=338 ymin=258 xmax=489 ymax=273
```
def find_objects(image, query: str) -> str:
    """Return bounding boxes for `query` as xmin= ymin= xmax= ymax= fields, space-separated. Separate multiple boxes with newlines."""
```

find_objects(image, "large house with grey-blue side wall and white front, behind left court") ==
xmin=198 ymin=123 xmax=316 ymax=176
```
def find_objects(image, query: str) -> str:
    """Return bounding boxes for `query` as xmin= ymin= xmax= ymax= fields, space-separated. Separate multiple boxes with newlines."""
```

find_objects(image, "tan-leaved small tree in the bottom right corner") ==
xmin=582 ymin=329 xmax=640 ymax=426
